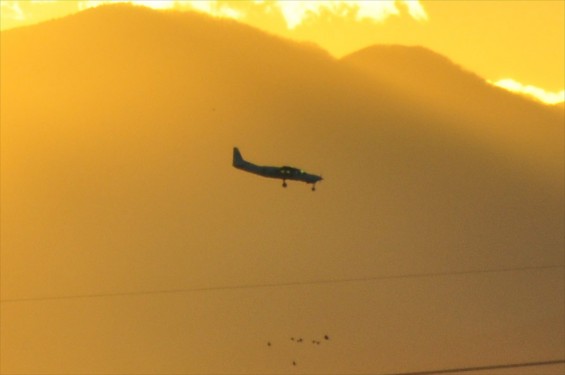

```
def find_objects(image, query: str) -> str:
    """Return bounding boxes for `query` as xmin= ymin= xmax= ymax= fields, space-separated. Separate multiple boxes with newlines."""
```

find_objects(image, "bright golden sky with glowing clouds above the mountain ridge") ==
xmin=1 ymin=0 xmax=565 ymax=103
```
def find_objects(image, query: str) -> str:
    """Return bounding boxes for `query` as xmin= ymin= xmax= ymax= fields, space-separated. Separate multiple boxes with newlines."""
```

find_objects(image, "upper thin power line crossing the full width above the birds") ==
xmin=0 ymin=265 xmax=565 ymax=304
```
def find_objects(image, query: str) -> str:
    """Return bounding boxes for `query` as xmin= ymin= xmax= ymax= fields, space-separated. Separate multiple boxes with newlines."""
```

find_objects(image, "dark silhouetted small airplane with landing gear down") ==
xmin=233 ymin=147 xmax=323 ymax=191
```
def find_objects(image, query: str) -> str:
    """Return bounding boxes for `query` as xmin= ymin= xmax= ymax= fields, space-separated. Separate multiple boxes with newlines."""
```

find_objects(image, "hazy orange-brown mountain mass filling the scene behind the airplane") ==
xmin=0 ymin=5 xmax=564 ymax=373
